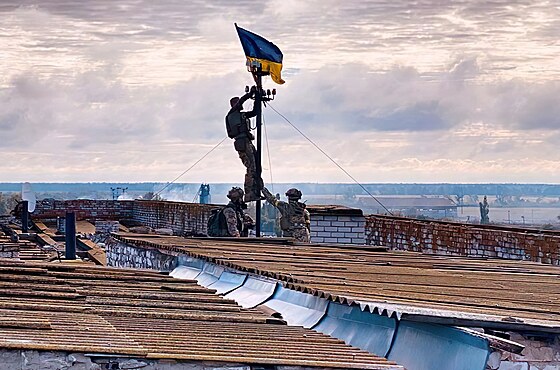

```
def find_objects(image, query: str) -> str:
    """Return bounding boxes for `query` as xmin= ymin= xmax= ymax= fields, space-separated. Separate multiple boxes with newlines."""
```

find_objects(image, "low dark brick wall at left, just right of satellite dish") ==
xmin=31 ymin=199 xmax=134 ymax=221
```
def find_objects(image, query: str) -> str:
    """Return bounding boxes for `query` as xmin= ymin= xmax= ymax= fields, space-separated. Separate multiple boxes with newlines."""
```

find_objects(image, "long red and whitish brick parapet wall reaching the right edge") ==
xmin=365 ymin=215 xmax=560 ymax=265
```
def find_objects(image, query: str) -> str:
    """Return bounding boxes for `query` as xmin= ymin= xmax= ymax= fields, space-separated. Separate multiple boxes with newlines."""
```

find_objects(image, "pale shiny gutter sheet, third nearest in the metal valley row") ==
xmin=264 ymin=286 xmax=329 ymax=328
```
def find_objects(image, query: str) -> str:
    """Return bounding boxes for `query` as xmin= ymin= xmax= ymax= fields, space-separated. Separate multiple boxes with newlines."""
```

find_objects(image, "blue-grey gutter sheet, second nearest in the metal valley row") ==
xmin=313 ymin=302 xmax=397 ymax=356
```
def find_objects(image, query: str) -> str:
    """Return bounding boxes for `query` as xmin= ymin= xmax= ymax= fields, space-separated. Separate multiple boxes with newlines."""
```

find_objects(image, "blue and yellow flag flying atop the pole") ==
xmin=235 ymin=23 xmax=284 ymax=84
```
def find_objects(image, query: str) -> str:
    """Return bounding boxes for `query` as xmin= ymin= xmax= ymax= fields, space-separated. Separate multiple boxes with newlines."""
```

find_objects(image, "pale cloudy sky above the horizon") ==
xmin=0 ymin=0 xmax=560 ymax=183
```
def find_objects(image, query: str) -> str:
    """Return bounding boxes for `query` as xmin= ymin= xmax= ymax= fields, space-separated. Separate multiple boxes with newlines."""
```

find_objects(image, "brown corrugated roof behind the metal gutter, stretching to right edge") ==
xmin=115 ymin=235 xmax=560 ymax=332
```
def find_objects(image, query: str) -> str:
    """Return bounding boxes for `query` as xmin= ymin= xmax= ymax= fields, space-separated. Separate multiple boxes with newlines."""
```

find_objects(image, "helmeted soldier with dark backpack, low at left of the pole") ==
xmin=208 ymin=187 xmax=255 ymax=238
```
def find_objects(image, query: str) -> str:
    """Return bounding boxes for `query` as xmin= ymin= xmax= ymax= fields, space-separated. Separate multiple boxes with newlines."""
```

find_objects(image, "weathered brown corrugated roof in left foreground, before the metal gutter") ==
xmin=0 ymin=259 xmax=402 ymax=369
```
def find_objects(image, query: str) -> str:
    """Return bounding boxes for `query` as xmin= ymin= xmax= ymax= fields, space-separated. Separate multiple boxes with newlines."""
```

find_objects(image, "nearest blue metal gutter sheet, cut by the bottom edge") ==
xmin=388 ymin=321 xmax=490 ymax=370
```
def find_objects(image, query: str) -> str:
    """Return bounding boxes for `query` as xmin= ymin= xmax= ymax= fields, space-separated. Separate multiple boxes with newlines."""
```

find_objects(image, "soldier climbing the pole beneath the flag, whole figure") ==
xmin=226 ymin=86 xmax=263 ymax=202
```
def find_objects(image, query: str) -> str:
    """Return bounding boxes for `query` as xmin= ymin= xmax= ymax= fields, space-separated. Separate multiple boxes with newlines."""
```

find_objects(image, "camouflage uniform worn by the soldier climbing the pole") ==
xmin=226 ymin=92 xmax=263 ymax=202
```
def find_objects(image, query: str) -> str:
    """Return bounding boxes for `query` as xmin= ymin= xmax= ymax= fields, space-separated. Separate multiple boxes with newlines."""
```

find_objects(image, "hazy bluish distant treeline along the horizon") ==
xmin=0 ymin=182 xmax=560 ymax=197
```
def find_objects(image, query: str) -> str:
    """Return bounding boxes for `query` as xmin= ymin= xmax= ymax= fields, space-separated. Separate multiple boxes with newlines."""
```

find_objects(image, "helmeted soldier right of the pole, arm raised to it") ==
xmin=263 ymin=188 xmax=311 ymax=243
